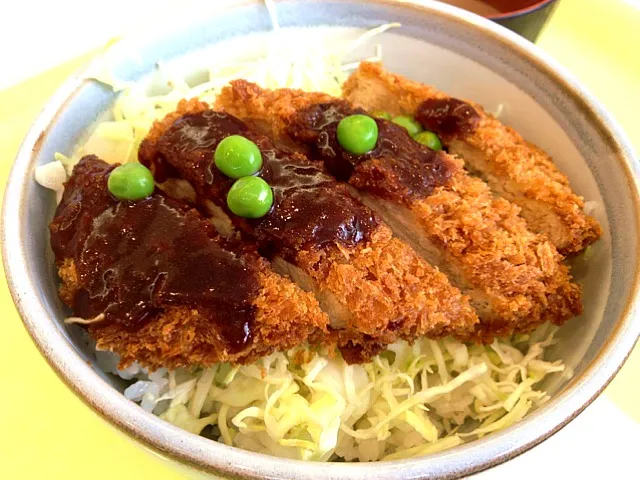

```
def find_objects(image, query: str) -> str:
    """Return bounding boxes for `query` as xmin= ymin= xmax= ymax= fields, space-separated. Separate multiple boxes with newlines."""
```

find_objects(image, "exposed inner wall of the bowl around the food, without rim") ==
xmin=34 ymin=9 xmax=612 ymax=391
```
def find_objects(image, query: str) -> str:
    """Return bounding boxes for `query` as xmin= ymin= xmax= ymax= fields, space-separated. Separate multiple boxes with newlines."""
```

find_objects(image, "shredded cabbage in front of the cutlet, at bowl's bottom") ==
xmin=114 ymin=326 xmax=564 ymax=461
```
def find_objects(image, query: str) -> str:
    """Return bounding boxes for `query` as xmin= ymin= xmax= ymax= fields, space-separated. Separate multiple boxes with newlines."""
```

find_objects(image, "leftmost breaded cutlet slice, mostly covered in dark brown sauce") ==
xmin=50 ymin=156 xmax=328 ymax=369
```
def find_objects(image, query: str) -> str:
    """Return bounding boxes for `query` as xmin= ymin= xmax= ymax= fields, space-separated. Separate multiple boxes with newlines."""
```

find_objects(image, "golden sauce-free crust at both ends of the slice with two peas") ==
xmin=140 ymin=100 xmax=478 ymax=347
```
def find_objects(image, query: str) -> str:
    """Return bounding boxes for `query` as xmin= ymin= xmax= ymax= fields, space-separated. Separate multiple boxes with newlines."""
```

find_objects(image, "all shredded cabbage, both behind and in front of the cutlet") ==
xmin=36 ymin=1 xmax=564 ymax=461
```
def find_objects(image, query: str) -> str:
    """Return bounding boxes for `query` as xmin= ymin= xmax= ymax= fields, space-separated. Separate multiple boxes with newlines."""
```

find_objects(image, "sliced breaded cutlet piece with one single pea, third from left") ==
xmin=217 ymin=80 xmax=581 ymax=341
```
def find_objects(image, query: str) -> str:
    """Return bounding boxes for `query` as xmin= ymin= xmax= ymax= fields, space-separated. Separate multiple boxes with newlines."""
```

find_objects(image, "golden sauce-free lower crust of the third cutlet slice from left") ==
xmin=412 ymin=163 xmax=582 ymax=341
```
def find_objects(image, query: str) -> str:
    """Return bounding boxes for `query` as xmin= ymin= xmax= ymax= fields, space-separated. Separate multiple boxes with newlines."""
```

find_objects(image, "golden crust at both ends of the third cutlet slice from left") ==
xmin=217 ymin=80 xmax=581 ymax=341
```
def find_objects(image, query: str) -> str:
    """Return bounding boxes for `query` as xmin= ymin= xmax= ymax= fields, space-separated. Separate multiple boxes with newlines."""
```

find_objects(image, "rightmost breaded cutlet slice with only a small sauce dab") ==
xmin=343 ymin=62 xmax=601 ymax=255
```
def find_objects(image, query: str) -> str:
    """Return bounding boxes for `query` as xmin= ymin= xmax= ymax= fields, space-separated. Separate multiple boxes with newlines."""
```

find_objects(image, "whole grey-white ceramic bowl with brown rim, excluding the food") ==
xmin=2 ymin=0 xmax=640 ymax=480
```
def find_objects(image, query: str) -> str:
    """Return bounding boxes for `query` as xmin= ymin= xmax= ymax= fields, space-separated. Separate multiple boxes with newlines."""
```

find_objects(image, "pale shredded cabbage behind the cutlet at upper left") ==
xmin=36 ymin=11 xmax=400 ymax=191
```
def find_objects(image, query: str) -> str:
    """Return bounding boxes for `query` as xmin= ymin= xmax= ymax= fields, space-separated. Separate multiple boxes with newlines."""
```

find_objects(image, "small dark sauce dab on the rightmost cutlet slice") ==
xmin=416 ymin=98 xmax=480 ymax=139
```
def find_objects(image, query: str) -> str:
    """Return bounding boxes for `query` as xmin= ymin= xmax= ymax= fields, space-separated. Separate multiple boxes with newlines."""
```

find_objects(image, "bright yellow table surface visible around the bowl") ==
xmin=0 ymin=0 xmax=640 ymax=480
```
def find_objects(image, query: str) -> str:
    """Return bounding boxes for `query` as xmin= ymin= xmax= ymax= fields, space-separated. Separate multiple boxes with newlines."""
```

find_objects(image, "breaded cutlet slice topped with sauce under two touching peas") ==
xmin=139 ymin=101 xmax=477 ymax=362
